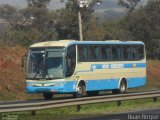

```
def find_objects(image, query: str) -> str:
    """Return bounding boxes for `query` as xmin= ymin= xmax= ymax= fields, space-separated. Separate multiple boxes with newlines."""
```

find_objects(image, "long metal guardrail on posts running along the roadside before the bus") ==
xmin=0 ymin=91 xmax=160 ymax=114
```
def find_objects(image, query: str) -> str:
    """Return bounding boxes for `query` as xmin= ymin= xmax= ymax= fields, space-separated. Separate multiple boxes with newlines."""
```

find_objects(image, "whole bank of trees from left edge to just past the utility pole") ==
xmin=0 ymin=0 xmax=104 ymax=46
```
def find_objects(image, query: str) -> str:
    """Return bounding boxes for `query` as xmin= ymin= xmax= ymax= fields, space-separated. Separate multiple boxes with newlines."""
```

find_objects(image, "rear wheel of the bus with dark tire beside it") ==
xmin=112 ymin=79 xmax=127 ymax=94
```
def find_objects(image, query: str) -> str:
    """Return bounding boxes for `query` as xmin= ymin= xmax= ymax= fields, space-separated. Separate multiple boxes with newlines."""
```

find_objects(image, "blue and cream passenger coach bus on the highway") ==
xmin=26 ymin=40 xmax=146 ymax=99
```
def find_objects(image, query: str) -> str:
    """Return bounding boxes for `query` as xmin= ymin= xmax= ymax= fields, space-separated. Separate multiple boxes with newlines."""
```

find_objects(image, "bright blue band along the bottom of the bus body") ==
xmin=26 ymin=77 xmax=146 ymax=93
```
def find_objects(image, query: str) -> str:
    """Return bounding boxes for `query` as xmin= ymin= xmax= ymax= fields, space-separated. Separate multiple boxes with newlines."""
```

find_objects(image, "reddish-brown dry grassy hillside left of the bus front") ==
xmin=0 ymin=46 xmax=25 ymax=100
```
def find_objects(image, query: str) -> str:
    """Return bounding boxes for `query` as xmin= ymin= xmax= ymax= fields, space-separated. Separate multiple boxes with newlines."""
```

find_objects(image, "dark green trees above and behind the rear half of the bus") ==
xmin=104 ymin=0 xmax=160 ymax=58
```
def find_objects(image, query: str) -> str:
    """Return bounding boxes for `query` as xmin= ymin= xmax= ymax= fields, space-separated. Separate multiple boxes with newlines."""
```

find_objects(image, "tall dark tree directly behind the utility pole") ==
xmin=57 ymin=0 xmax=101 ymax=40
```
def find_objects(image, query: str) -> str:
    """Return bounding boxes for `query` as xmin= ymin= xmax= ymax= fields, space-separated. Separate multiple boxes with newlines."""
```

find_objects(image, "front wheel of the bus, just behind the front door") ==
xmin=73 ymin=83 xmax=86 ymax=98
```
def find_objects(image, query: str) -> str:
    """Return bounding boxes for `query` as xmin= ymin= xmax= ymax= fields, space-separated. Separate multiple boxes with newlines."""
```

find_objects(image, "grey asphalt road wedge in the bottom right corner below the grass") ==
xmin=73 ymin=109 xmax=160 ymax=120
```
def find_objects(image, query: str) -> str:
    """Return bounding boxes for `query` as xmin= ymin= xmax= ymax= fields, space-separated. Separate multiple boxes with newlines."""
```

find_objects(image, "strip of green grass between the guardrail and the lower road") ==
xmin=1 ymin=98 xmax=160 ymax=120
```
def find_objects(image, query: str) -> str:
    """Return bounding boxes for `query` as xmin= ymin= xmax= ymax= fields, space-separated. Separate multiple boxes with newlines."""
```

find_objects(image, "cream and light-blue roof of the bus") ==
xmin=30 ymin=40 xmax=144 ymax=47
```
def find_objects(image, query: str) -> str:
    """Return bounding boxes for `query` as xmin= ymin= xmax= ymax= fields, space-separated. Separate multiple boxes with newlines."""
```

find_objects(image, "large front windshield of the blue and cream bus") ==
xmin=26 ymin=48 xmax=64 ymax=79
